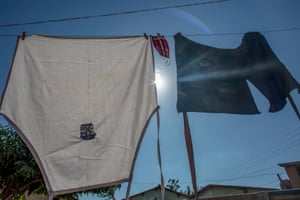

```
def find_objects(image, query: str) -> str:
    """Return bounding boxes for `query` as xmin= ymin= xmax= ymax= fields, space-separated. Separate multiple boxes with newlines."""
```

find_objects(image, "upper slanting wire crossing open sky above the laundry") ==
xmin=0 ymin=0 xmax=231 ymax=28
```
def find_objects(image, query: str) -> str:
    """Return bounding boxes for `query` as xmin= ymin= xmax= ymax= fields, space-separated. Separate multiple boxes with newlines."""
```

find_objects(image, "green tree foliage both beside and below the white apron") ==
xmin=0 ymin=125 xmax=121 ymax=200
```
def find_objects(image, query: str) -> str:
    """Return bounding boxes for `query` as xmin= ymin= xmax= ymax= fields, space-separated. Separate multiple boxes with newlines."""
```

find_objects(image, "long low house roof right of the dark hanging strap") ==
xmin=190 ymin=184 xmax=277 ymax=199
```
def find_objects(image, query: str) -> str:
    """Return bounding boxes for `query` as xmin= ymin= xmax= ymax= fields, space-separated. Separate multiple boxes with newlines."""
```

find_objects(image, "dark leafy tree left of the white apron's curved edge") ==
xmin=0 ymin=126 xmax=43 ymax=199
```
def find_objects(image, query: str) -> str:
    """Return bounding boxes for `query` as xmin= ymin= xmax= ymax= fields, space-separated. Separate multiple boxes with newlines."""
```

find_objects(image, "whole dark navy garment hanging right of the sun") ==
xmin=174 ymin=32 xmax=300 ymax=114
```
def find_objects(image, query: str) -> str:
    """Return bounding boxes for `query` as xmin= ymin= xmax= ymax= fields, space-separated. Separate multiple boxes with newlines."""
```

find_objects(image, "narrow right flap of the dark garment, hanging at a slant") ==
xmin=242 ymin=32 xmax=300 ymax=112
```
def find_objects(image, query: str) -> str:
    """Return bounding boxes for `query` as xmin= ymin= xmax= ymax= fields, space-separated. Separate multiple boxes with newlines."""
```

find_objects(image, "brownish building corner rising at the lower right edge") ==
xmin=278 ymin=161 xmax=300 ymax=189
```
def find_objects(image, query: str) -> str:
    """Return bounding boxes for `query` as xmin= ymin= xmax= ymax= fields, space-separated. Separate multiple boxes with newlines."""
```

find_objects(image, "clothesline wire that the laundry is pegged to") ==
xmin=0 ymin=27 xmax=300 ymax=37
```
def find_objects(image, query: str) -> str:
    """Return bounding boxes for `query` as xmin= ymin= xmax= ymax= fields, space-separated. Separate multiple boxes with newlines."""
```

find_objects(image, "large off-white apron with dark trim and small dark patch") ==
xmin=0 ymin=36 xmax=158 ymax=194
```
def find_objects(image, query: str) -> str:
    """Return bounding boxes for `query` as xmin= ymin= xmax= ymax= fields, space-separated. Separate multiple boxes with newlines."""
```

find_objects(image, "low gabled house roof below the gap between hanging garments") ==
xmin=129 ymin=185 xmax=188 ymax=200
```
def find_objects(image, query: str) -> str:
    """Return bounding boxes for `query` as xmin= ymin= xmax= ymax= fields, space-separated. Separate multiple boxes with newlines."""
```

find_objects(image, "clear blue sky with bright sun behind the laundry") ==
xmin=0 ymin=0 xmax=300 ymax=199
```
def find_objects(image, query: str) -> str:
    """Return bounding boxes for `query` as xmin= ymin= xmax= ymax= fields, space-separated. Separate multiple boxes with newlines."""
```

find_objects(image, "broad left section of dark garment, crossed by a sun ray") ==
xmin=174 ymin=33 xmax=259 ymax=114
